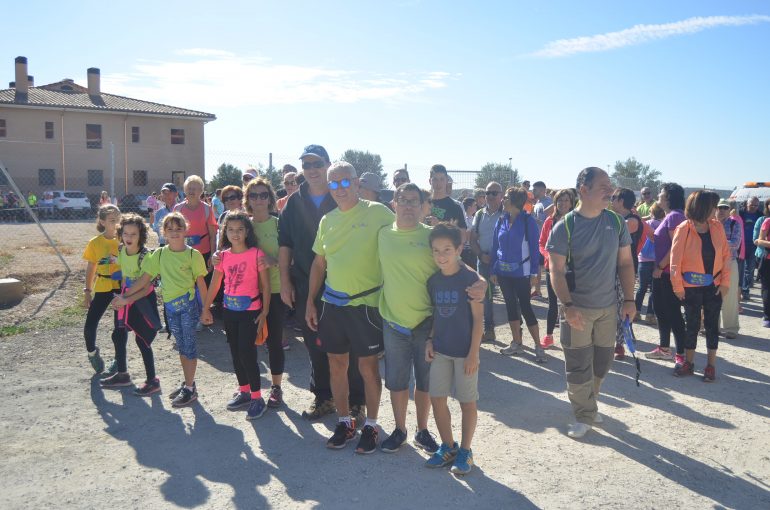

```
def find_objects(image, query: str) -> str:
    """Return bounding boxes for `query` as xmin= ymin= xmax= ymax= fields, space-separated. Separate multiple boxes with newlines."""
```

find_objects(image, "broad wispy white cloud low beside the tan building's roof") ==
xmin=102 ymin=48 xmax=458 ymax=109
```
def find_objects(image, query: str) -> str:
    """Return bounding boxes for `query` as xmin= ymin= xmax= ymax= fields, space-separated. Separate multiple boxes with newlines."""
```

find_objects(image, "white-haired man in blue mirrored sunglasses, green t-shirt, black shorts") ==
xmin=305 ymin=161 xmax=393 ymax=454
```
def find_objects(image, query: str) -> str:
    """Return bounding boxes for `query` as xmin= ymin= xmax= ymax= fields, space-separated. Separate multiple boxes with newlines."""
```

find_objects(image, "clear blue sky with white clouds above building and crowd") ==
xmin=0 ymin=0 xmax=770 ymax=189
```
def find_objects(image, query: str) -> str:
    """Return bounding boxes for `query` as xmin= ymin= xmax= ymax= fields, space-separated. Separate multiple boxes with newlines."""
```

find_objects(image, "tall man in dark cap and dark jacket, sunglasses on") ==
xmin=278 ymin=145 xmax=364 ymax=420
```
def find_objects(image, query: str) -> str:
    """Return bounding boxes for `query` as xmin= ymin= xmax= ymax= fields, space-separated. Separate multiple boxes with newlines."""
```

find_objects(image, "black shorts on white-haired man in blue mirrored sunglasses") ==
xmin=318 ymin=302 xmax=385 ymax=357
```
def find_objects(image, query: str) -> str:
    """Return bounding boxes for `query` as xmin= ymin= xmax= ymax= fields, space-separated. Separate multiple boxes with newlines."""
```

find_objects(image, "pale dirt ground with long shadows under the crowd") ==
xmin=0 ymin=264 xmax=770 ymax=509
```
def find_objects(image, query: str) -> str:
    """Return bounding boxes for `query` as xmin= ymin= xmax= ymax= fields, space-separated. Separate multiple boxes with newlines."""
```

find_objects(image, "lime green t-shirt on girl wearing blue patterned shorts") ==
xmin=142 ymin=246 xmax=208 ymax=303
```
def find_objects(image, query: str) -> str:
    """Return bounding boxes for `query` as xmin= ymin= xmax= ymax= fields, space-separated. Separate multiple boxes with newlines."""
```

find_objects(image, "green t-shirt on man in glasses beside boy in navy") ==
xmin=378 ymin=223 xmax=438 ymax=329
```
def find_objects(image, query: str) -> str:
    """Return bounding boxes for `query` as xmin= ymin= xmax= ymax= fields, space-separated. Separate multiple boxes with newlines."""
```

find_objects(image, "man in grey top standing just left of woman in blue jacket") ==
xmin=471 ymin=181 xmax=503 ymax=342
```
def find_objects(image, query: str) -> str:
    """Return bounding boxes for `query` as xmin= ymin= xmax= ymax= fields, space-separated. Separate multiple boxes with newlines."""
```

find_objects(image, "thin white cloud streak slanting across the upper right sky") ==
xmin=532 ymin=14 xmax=770 ymax=58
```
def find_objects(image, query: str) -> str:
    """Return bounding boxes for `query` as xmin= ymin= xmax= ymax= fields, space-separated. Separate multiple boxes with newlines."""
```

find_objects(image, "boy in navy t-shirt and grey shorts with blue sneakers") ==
xmin=425 ymin=223 xmax=484 ymax=475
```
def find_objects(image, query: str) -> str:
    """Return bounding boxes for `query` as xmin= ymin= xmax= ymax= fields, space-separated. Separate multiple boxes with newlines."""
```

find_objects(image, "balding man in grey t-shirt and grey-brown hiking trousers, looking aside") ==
xmin=546 ymin=167 xmax=636 ymax=439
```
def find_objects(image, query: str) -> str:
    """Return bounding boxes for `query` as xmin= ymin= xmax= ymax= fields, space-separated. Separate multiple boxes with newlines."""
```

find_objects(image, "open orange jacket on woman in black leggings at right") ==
xmin=671 ymin=218 xmax=730 ymax=292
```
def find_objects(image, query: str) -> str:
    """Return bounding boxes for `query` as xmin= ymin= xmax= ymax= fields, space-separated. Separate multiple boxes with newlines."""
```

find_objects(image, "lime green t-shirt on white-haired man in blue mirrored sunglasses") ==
xmin=313 ymin=200 xmax=394 ymax=306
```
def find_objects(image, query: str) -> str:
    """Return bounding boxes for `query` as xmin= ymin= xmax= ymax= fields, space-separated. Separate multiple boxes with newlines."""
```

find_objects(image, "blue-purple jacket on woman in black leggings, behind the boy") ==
xmin=490 ymin=211 xmax=540 ymax=277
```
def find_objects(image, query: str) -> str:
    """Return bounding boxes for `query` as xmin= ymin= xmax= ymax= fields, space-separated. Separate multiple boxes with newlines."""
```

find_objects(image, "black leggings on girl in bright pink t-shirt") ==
xmin=222 ymin=309 xmax=261 ymax=391
